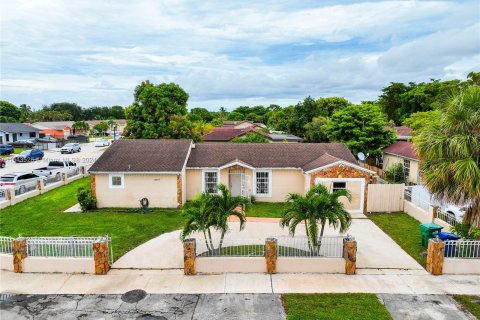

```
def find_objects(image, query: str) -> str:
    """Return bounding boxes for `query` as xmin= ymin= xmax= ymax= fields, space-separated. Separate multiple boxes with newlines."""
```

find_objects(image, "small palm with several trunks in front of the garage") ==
xmin=280 ymin=184 xmax=352 ymax=254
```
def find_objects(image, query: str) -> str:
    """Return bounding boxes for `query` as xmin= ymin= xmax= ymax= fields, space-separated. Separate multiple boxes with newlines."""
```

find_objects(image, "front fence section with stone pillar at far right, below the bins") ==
xmin=427 ymin=239 xmax=480 ymax=275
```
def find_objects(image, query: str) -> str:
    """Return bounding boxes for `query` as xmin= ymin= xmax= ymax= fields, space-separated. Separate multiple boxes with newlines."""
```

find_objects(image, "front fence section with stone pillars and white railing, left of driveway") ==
xmin=0 ymin=236 xmax=113 ymax=275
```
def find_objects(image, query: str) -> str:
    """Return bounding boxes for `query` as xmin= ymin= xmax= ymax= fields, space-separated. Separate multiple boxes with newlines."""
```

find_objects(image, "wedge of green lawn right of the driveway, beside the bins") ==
xmin=368 ymin=212 xmax=427 ymax=267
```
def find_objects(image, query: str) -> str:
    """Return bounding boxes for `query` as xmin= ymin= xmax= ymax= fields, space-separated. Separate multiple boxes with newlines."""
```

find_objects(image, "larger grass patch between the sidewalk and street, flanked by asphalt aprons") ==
xmin=282 ymin=293 xmax=392 ymax=320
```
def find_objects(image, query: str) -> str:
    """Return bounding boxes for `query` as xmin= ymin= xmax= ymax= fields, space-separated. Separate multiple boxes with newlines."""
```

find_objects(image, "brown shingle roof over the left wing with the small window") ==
xmin=89 ymin=139 xmax=191 ymax=172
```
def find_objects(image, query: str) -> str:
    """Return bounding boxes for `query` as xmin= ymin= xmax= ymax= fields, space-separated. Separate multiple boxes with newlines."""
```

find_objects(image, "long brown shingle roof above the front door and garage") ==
xmin=187 ymin=142 xmax=356 ymax=170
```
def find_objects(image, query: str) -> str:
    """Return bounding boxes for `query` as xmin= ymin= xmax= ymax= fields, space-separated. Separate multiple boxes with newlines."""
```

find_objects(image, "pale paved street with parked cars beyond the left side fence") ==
xmin=0 ymin=142 xmax=107 ymax=175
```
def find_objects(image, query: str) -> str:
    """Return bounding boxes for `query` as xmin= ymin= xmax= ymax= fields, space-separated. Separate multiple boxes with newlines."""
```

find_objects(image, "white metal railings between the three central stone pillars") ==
xmin=196 ymin=236 xmax=345 ymax=258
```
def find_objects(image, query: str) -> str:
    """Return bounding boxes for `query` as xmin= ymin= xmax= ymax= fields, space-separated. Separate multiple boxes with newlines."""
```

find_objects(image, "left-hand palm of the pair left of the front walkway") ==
xmin=180 ymin=193 xmax=214 ymax=253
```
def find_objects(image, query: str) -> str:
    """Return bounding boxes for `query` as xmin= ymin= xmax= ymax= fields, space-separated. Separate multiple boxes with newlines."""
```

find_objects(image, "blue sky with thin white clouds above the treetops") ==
xmin=0 ymin=0 xmax=480 ymax=110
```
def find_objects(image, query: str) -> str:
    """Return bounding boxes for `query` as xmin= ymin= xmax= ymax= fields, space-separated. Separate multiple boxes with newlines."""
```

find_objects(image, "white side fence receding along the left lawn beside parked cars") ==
xmin=0 ymin=166 xmax=88 ymax=209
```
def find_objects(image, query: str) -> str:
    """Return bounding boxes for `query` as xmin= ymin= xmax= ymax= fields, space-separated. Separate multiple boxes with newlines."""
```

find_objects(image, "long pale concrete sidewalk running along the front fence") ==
xmin=0 ymin=270 xmax=480 ymax=294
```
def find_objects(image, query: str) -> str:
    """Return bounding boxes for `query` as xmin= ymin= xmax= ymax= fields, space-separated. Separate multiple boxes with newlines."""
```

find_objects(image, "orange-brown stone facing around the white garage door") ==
xmin=310 ymin=165 xmax=376 ymax=213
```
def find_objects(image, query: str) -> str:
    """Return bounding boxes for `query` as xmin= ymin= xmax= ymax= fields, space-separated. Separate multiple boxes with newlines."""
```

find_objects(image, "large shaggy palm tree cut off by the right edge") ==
xmin=414 ymin=86 xmax=480 ymax=227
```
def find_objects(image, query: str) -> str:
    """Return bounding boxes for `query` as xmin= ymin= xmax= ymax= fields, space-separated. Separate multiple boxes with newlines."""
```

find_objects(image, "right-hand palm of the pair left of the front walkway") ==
xmin=212 ymin=184 xmax=248 ymax=252
